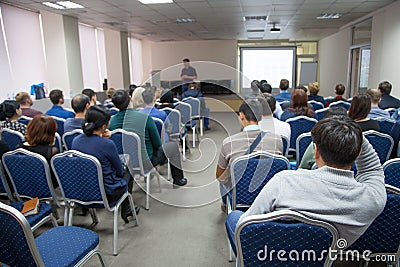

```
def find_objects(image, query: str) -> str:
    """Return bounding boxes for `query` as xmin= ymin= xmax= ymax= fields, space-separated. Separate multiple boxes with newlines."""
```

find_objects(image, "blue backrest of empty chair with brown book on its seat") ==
xmin=3 ymin=148 xmax=57 ymax=201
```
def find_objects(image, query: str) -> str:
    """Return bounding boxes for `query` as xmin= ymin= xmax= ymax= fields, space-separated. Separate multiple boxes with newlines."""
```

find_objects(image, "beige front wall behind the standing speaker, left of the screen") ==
xmin=142 ymin=40 xmax=237 ymax=80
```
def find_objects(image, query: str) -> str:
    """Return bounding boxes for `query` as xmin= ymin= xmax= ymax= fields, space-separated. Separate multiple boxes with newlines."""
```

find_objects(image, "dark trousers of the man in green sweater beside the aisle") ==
xmin=146 ymin=142 xmax=183 ymax=181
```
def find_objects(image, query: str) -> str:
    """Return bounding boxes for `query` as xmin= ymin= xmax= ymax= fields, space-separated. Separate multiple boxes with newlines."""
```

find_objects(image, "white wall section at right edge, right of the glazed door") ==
xmin=369 ymin=1 xmax=400 ymax=97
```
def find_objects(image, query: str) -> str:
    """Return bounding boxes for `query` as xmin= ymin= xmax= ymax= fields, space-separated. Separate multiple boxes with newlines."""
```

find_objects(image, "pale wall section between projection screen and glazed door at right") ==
xmin=318 ymin=28 xmax=351 ymax=96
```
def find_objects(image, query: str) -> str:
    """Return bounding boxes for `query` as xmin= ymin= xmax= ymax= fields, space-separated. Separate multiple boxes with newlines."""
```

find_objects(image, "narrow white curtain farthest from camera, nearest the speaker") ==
xmin=128 ymin=37 xmax=143 ymax=85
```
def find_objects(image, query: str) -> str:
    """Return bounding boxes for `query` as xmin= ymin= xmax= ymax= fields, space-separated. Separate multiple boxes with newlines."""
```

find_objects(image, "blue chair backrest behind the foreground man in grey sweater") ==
xmin=235 ymin=210 xmax=338 ymax=267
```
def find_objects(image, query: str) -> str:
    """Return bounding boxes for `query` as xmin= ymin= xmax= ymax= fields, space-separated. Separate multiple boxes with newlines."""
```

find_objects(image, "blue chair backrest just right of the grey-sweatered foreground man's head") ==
xmin=363 ymin=130 xmax=394 ymax=164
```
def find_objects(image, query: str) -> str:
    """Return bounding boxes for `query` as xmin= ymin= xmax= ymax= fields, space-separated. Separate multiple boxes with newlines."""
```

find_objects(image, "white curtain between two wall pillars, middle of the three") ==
xmin=79 ymin=24 xmax=107 ymax=91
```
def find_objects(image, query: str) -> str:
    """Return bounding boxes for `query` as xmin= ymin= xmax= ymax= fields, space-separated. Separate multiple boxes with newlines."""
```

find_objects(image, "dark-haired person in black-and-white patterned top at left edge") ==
xmin=0 ymin=100 xmax=26 ymax=135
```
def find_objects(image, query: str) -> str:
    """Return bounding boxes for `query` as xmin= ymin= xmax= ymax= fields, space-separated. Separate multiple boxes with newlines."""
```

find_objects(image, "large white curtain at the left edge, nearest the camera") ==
xmin=0 ymin=4 xmax=48 ymax=100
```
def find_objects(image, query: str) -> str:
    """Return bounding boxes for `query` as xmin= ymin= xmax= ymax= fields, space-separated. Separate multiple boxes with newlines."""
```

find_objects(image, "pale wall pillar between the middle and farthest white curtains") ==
xmin=104 ymin=29 xmax=124 ymax=88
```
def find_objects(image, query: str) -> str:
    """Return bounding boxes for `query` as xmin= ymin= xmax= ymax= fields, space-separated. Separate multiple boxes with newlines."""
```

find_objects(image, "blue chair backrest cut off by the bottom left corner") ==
xmin=0 ymin=203 xmax=44 ymax=267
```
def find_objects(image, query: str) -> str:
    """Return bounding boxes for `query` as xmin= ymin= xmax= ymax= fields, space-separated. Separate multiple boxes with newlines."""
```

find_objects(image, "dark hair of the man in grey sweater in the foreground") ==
xmin=311 ymin=116 xmax=363 ymax=169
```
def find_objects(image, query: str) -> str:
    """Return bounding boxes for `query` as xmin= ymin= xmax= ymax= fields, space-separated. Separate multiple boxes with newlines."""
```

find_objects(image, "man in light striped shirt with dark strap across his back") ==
xmin=216 ymin=99 xmax=283 ymax=212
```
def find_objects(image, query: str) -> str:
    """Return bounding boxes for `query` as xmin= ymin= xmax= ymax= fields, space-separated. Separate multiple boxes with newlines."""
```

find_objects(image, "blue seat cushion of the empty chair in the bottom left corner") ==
xmin=35 ymin=226 xmax=99 ymax=267
